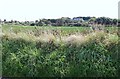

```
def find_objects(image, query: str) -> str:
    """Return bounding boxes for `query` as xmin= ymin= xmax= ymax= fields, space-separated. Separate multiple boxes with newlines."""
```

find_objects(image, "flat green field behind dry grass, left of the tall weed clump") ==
xmin=3 ymin=25 xmax=89 ymax=34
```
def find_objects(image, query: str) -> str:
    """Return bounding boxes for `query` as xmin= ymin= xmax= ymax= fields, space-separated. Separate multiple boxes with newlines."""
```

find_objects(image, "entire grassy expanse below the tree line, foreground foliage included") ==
xmin=2 ymin=25 xmax=120 ymax=77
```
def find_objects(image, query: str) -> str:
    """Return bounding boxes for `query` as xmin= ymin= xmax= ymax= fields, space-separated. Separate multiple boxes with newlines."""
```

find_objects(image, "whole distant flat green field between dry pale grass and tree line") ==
xmin=2 ymin=25 xmax=118 ymax=35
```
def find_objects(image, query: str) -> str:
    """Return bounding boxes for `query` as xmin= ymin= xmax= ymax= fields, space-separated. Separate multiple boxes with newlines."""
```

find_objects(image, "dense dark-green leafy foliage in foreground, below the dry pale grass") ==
xmin=2 ymin=31 xmax=119 ymax=77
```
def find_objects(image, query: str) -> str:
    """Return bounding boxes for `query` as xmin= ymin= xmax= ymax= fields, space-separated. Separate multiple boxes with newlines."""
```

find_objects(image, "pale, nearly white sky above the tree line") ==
xmin=0 ymin=0 xmax=120 ymax=21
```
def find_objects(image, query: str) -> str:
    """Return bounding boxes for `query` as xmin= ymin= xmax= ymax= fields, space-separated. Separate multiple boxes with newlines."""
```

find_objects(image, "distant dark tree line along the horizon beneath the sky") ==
xmin=0 ymin=17 xmax=120 ymax=26
